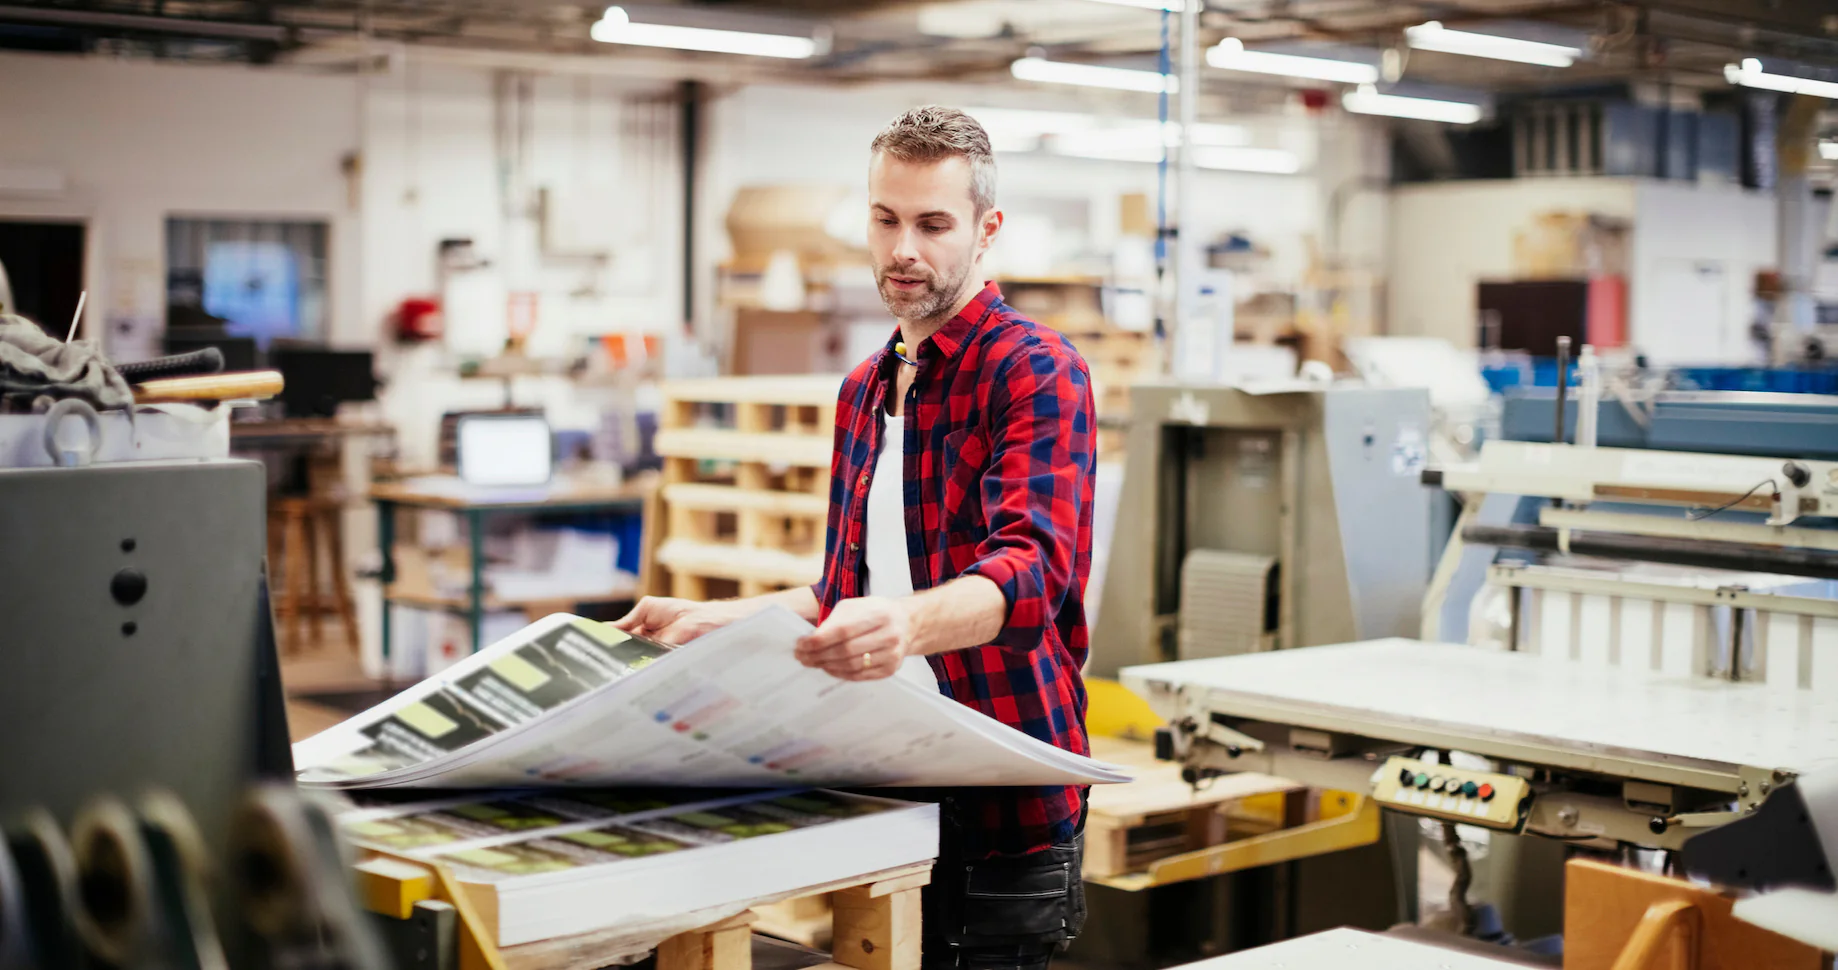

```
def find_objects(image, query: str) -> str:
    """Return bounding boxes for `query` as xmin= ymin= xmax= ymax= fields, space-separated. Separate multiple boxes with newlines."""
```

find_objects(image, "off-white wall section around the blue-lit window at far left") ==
xmin=0 ymin=53 xmax=362 ymax=350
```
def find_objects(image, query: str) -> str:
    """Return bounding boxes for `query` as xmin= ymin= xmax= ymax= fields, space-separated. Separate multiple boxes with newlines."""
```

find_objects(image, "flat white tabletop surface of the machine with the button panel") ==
xmin=1123 ymin=639 xmax=1838 ymax=781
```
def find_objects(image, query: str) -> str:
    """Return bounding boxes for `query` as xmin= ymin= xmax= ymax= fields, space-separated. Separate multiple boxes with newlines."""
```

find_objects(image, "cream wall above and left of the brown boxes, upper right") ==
xmin=1388 ymin=178 xmax=1636 ymax=347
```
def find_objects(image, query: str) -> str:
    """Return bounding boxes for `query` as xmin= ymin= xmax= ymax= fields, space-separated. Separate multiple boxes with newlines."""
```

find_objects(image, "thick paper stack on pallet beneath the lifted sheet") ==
xmin=338 ymin=790 xmax=937 ymax=946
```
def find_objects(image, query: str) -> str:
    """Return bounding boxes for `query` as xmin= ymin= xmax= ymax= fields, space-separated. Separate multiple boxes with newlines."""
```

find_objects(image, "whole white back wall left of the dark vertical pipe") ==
xmin=0 ymin=53 xmax=682 ymax=360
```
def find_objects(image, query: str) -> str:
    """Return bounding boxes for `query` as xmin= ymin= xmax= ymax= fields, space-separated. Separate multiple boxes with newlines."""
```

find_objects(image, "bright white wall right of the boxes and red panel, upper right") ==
xmin=1628 ymin=182 xmax=1779 ymax=364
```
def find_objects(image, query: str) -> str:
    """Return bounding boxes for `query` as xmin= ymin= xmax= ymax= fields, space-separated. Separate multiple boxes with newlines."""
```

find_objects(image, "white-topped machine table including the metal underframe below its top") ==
xmin=1123 ymin=639 xmax=1838 ymax=849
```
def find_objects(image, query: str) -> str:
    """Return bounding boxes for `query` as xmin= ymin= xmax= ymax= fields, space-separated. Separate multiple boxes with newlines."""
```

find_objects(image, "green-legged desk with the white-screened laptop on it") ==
xmin=369 ymin=476 xmax=654 ymax=660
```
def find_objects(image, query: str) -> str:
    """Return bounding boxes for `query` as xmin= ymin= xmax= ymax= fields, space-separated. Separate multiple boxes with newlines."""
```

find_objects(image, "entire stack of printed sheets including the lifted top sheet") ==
xmin=294 ymin=608 xmax=1129 ymax=946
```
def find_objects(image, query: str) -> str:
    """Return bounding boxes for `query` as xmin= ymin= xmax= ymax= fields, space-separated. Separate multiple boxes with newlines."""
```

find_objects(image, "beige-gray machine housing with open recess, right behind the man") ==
xmin=1090 ymin=382 xmax=1432 ymax=678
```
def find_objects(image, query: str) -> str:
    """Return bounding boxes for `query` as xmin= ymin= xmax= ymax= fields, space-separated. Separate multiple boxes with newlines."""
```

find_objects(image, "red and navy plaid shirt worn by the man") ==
xmin=814 ymin=283 xmax=1097 ymax=854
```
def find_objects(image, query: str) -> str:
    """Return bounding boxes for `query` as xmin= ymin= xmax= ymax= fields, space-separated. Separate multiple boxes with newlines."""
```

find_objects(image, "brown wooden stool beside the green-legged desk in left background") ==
xmin=268 ymin=496 xmax=358 ymax=652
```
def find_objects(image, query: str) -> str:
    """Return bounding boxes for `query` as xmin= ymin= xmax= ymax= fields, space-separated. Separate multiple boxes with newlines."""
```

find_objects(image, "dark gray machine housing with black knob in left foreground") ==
xmin=0 ymin=459 xmax=292 ymax=858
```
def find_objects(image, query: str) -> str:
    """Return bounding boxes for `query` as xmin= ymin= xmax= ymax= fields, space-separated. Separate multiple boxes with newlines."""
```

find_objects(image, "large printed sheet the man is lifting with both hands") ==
xmin=294 ymin=608 xmax=1129 ymax=788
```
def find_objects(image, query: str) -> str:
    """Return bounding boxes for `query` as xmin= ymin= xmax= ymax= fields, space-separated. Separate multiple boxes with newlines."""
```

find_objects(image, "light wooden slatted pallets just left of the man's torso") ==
xmin=643 ymin=377 xmax=842 ymax=599
